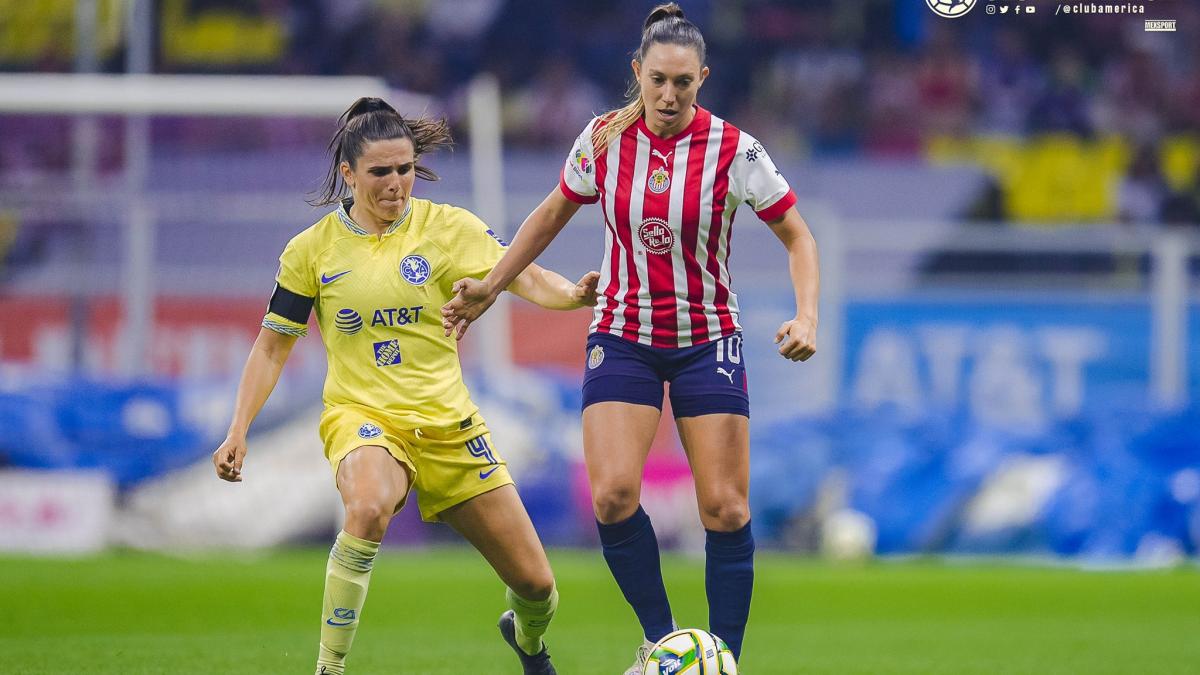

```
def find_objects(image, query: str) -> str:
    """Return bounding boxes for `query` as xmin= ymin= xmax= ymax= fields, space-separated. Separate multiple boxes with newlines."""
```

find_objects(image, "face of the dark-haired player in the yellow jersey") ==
xmin=341 ymin=138 xmax=416 ymax=225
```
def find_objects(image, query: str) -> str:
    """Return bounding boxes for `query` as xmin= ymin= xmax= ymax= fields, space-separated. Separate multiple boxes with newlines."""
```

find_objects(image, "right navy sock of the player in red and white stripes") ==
xmin=704 ymin=514 xmax=754 ymax=658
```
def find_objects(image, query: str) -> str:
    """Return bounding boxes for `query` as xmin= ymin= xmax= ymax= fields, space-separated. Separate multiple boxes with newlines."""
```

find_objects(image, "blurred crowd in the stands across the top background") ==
xmin=0 ymin=0 xmax=1200 ymax=222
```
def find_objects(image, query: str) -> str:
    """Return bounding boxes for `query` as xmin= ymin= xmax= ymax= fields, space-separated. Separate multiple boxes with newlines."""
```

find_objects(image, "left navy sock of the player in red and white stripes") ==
xmin=596 ymin=506 xmax=681 ymax=646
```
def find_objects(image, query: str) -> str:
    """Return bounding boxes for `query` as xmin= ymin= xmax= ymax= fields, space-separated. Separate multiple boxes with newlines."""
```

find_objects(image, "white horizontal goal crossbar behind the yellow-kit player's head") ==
xmin=0 ymin=73 xmax=432 ymax=117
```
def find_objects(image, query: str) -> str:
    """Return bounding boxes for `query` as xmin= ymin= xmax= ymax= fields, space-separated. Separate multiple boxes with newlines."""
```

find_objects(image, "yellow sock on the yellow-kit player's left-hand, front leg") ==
xmin=317 ymin=531 xmax=379 ymax=675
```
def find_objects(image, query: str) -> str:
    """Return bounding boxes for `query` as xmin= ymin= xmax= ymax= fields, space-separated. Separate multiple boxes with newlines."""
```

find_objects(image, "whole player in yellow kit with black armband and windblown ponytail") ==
xmin=212 ymin=98 xmax=599 ymax=675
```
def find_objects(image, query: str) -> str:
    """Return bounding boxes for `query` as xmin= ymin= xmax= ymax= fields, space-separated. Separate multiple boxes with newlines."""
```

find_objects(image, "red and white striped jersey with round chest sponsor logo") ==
xmin=559 ymin=106 xmax=796 ymax=347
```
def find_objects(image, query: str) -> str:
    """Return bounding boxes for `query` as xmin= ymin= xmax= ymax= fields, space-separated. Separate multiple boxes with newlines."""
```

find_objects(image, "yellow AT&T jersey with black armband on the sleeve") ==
xmin=263 ymin=198 xmax=505 ymax=429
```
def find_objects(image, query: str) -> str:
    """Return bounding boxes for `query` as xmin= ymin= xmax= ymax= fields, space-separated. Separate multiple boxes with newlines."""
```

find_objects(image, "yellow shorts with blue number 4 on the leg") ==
xmin=320 ymin=405 xmax=512 ymax=522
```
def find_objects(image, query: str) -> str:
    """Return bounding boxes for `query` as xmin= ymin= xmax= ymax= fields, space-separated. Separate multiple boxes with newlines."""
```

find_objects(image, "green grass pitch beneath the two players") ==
xmin=0 ymin=549 xmax=1200 ymax=675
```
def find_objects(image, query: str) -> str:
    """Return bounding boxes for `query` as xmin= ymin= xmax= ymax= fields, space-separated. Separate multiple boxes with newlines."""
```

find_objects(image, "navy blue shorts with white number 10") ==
xmin=583 ymin=333 xmax=750 ymax=417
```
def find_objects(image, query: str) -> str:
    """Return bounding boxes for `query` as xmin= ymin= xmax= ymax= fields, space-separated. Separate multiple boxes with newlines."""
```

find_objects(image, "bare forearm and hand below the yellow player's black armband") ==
xmin=212 ymin=328 xmax=296 ymax=483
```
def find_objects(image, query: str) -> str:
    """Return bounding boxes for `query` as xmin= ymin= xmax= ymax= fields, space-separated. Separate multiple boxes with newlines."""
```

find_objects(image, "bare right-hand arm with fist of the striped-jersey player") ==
xmin=767 ymin=207 xmax=821 ymax=362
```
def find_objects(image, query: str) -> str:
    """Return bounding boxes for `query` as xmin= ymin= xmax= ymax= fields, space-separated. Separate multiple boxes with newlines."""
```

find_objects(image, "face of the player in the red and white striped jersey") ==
xmin=634 ymin=43 xmax=708 ymax=136
